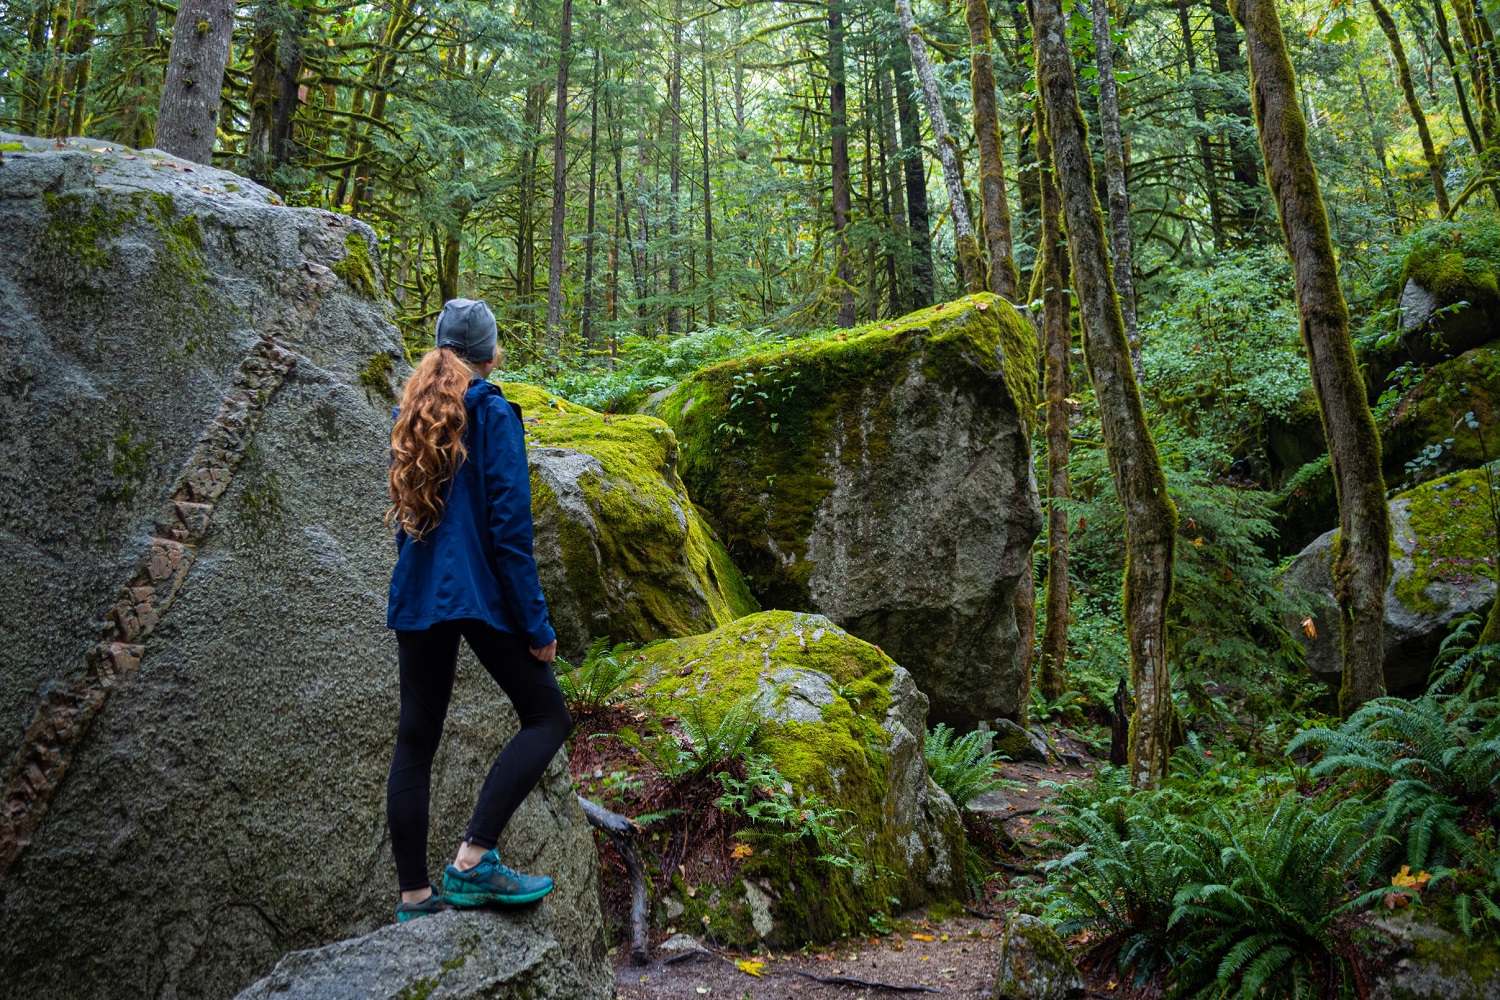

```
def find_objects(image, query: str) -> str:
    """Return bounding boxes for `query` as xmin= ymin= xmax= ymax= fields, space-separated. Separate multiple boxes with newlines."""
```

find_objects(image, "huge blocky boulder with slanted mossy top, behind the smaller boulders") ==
xmin=657 ymin=294 xmax=1041 ymax=727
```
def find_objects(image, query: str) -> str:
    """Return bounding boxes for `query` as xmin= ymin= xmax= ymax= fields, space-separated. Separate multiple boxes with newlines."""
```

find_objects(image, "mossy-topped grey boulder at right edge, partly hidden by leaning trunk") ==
xmin=1283 ymin=469 xmax=1497 ymax=693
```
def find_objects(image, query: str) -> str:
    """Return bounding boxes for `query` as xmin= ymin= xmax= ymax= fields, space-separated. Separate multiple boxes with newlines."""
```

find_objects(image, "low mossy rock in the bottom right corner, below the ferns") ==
xmin=1370 ymin=910 xmax=1500 ymax=1000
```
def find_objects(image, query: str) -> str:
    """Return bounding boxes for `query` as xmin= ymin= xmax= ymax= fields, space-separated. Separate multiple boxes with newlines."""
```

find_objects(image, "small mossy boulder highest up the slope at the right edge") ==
xmin=1400 ymin=220 xmax=1500 ymax=363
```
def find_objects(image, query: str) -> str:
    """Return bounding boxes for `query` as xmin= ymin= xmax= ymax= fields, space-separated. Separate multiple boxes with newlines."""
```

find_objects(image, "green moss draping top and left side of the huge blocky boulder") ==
xmin=660 ymin=294 xmax=1037 ymax=609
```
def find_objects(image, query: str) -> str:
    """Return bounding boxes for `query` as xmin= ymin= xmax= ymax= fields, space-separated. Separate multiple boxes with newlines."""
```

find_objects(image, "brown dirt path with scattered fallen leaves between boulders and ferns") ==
xmin=615 ymin=745 xmax=1118 ymax=1000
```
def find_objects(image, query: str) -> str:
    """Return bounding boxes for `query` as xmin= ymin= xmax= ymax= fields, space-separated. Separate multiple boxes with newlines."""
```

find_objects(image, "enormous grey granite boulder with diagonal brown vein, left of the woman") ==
xmin=0 ymin=136 xmax=611 ymax=1000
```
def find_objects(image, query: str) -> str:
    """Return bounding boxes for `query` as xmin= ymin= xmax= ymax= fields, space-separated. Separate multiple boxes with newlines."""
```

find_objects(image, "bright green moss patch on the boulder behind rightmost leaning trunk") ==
xmin=1395 ymin=469 xmax=1496 ymax=613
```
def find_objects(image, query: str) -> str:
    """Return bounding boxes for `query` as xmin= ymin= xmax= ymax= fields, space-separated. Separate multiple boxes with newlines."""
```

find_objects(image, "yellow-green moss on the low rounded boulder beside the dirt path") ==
xmin=641 ymin=612 xmax=926 ymax=945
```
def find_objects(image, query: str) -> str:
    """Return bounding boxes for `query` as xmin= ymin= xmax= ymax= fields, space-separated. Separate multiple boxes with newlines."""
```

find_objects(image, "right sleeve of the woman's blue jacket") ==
xmin=476 ymin=393 xmax=557 ymax=649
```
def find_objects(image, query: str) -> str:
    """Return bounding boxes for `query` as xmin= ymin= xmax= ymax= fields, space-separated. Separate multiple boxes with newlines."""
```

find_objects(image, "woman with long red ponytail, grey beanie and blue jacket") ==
xmin=386 ymin=298 xmax=573 ymax=921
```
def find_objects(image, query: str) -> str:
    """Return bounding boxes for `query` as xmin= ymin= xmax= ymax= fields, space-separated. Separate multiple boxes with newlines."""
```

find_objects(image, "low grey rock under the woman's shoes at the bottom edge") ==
xmin=237 ymin=904 xmax=614 ymax=1000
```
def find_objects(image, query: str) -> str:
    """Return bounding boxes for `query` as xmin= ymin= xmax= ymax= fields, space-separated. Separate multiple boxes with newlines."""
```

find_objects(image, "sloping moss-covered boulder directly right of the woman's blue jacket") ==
xmin=501 ymin=382 xmax=759 ymax=660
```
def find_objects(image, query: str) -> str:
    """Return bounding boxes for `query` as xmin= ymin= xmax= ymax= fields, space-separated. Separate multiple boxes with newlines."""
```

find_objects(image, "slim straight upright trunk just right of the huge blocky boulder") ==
xmin=1031 ymin=105 xmax=1073 ymax=702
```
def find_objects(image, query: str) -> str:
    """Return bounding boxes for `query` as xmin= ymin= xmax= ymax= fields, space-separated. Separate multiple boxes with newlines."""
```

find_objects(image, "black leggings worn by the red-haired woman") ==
xmin=386 ymin=618 xmax=573 ymax=892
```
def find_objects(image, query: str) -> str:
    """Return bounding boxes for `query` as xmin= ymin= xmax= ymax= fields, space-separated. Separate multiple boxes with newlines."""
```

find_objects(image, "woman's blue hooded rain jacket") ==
xmin=386 ymin=376 xmax=557 ymax=649
